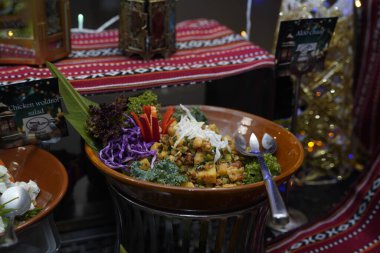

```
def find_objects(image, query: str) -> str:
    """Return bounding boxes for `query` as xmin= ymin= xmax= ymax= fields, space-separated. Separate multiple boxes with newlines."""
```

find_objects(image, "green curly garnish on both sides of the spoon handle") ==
xmin=243 ymin=154 xmax=281 ymax=184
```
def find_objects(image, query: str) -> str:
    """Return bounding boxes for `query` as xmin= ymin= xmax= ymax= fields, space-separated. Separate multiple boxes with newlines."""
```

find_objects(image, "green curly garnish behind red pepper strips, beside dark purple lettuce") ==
xmin=127 ymin=91 xmax=160 ymax=115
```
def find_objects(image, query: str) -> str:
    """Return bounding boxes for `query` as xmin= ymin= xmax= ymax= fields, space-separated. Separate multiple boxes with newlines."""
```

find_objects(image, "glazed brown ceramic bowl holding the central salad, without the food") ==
xmin=85 ymin=105 xmax=304 ymax=213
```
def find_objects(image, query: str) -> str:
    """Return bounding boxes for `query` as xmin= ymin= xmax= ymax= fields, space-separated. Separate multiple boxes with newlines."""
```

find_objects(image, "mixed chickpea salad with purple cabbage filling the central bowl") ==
xmin=86 ymin=91 xmax=280 ymax=188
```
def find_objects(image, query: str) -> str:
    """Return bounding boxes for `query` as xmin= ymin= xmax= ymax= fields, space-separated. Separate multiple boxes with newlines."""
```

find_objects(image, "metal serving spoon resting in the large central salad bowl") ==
xmin=235 ymin=133 xmax=289 ymax=225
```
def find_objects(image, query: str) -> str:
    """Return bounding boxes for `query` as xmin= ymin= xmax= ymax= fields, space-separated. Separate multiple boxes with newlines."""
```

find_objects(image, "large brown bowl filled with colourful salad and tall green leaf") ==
xmin=47 ymin=64 xmax=303 ymax=211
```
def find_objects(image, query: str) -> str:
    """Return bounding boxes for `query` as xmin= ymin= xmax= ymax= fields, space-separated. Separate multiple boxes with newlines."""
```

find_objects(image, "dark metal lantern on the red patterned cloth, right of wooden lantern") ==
xmin=119 ymin=0 xmax=176 ymax=60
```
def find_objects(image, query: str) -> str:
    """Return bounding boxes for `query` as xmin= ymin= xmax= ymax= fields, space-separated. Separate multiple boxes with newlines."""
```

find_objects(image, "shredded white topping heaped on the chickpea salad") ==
xmin=174 ymin=105 xmax=228 ymax=162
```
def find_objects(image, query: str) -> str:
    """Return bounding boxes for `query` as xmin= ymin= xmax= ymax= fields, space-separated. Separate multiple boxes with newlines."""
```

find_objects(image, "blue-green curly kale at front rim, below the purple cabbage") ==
xmin=130 ymin=160 xmax=188 ymax=186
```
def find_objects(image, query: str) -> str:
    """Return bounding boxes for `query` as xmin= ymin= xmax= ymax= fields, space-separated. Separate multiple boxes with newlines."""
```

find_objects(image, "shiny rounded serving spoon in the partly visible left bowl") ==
xmin=0 ymin=186 xmax=32 ymax=247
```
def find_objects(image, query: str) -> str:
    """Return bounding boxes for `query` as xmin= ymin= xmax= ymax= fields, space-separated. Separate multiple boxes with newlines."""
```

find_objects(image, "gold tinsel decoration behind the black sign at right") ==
xmin=276 ymin=0 xmax=356 ymax=184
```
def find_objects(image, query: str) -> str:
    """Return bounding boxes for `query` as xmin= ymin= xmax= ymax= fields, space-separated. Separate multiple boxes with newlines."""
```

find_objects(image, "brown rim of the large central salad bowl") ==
xmin=85 ymin=105 xmax=304 ymax=194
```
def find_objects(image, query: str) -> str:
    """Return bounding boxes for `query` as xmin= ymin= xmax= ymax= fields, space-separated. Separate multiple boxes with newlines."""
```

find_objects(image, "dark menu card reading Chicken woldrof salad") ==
xmin=0 ymin=78 xmax=68 ymax=148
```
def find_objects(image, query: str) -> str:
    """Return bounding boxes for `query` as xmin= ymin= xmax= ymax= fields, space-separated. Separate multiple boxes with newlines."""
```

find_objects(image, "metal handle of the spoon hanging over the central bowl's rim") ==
xmin=257 ymin=155 xmax=289 ymax=225
